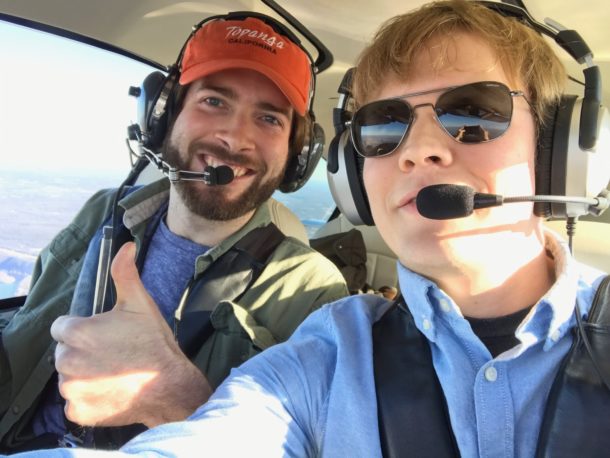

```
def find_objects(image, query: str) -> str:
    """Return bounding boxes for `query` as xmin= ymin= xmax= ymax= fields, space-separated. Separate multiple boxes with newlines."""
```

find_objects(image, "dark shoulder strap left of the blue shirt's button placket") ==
xmin=373 ymin=296 xmax=459 ymax=457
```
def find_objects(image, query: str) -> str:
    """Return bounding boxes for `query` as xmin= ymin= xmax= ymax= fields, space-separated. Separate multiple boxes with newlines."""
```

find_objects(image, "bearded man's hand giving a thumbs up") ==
xmin=51 ymin=242 xmax=212 ymax=427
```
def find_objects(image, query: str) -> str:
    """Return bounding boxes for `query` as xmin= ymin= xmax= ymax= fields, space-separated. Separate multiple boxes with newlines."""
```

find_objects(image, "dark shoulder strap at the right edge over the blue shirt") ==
xmin=537 ymin=276 xmax=610 ymax=457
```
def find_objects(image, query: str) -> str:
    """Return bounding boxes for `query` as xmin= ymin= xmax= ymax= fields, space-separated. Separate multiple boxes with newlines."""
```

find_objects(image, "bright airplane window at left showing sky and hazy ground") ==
xmin=0 ymin=23 xmax=152 ymax=299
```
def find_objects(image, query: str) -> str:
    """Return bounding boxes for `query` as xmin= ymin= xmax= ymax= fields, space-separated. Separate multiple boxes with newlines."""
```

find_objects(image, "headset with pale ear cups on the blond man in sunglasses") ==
xmin=327 ymin=1 xmax=610 ymax=226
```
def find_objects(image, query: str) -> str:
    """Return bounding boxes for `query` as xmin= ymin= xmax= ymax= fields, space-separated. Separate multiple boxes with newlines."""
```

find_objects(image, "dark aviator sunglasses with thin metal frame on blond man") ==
xmin=349 ymin=81 xmax=529 ymax=157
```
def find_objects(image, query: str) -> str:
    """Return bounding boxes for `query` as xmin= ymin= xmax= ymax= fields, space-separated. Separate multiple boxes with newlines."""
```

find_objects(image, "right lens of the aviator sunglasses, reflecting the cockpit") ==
xmin=435 ymin=82 xmax=513 ymax=143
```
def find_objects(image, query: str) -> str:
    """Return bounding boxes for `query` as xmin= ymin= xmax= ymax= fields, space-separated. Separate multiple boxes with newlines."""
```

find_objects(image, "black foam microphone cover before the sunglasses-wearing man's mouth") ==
xmin=415 ymin=184 xmax=474 ymax=219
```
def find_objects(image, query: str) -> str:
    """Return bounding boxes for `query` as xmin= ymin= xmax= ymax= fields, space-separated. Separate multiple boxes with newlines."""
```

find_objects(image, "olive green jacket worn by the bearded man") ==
xmin=0 ymin=179 xmax=348 ymax=446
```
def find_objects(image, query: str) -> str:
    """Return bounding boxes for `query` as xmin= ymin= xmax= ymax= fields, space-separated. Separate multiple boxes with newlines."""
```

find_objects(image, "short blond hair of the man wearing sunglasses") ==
xmin=352 ymin=0 xmax=566 ymax=122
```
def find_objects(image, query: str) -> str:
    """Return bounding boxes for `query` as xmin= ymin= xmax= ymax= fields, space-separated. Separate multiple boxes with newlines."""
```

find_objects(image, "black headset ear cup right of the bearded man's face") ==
xmin=279 ymin=118 xmax=326 ymax=193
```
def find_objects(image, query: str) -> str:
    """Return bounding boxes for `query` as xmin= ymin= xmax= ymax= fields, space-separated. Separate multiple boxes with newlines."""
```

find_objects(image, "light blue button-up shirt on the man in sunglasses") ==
xmin=8 ymin=234 xmax=604 ymax=458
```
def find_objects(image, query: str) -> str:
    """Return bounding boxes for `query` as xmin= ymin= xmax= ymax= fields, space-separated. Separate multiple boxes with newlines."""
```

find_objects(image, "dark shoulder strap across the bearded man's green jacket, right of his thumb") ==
xmin=174 ymin=223 xmax=286 ymax=358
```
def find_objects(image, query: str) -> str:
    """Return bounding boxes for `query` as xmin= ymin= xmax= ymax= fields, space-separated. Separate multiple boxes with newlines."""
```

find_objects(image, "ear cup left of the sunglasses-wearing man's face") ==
xmin=327 ymin=130 xmax=375 ymax=226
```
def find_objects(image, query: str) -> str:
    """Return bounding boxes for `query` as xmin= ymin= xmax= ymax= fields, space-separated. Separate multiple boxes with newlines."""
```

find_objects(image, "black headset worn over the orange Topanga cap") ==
xmin=128 ymin=0 xmax=333 ymax=193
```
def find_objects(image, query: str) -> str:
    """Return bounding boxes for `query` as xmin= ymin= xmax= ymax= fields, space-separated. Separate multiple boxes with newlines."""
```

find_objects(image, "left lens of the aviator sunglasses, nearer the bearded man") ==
xmin=351 ymin=100 xmax=412 ymax=157
